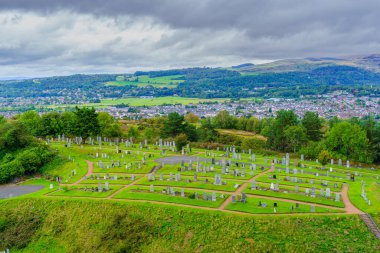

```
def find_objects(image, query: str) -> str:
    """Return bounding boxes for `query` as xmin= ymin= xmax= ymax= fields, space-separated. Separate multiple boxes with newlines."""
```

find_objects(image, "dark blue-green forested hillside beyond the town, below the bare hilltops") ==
xmin=0 ymin=66 xmax=380 ymax=102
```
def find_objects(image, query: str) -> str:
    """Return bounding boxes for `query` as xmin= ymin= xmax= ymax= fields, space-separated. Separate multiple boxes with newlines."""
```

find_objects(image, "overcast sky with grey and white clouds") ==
xmin=0 ymin=0 xmax=380 ymax=79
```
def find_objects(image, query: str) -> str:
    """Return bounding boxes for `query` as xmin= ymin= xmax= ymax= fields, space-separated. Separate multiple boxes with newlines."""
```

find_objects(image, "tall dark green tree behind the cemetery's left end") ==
xmin=74 ymin=107 xmax=100 ymax=143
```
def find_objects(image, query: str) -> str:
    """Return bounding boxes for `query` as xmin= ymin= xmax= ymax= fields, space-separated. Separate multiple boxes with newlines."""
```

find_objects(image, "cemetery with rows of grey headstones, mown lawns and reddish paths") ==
xmin=31 ymin=136 xmax=380 ymax=215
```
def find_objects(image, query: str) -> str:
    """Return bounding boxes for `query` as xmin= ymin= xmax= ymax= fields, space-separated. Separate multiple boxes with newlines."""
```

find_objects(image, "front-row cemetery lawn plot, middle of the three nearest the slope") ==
xmin=113 ymin=186 xmax=228 ymax=207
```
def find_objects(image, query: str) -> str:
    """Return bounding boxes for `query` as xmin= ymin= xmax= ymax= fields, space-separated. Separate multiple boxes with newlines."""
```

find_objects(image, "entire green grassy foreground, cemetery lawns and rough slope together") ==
xmin=0 ymin=138 xmax=380 ymax=252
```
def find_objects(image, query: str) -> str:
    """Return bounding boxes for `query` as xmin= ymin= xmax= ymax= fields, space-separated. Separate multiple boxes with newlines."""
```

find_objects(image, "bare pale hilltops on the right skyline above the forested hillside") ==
xmin=239 ymin=54 xmax=380 ymax=73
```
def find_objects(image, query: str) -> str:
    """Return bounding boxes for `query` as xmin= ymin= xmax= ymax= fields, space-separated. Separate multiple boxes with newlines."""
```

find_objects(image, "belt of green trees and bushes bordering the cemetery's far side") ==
xmin=0 ymin=107 xmax=380 ymax=182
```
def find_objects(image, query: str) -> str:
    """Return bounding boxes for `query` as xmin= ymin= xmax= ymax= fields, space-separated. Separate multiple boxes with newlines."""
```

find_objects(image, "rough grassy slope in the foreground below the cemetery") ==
xmin=0 ymin=199 xmax=380 ymax=252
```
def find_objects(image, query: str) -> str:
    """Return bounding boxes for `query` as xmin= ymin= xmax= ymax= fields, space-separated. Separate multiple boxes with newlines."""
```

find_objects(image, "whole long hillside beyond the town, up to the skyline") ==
xmin=0 ymin=54 xmax=380 ymax=101
